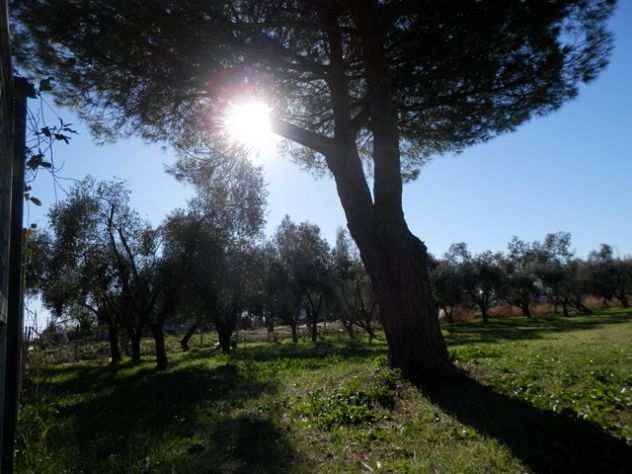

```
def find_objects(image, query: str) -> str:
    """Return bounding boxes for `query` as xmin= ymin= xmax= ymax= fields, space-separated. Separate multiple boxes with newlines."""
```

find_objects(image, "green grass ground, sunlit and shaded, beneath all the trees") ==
xmin=17 ymin=311 xmax=632 ymax=474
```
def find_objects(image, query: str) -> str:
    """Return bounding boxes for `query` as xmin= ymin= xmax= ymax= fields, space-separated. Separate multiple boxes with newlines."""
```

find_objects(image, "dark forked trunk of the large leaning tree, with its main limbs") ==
xmin=277 ymin=2 xmax=451 ymax=381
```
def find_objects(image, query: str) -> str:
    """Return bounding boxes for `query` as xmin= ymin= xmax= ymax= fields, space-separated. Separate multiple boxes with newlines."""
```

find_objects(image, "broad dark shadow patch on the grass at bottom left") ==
xmin=40 ymin=364 xmax=293 ymax=473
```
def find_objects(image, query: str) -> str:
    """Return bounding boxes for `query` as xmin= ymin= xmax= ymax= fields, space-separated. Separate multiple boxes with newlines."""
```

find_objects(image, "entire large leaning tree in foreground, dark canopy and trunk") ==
xmin=13 ymin=0 xmax=615 ymax=377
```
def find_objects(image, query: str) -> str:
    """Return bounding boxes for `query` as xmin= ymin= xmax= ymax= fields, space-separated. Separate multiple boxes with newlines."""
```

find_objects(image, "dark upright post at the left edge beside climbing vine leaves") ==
xmin=1 ymin=78 xmax=30 ymax=474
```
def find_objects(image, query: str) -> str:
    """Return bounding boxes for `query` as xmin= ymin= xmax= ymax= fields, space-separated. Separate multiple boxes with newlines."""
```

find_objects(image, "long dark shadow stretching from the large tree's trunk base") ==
xmin=418 ymin=372 xmax=632 ymax=474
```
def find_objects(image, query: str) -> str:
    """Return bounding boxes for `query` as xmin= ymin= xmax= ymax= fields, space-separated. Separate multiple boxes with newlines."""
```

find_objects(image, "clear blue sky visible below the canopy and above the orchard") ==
xmin=29 ymin=0 xmax=632 ymax=256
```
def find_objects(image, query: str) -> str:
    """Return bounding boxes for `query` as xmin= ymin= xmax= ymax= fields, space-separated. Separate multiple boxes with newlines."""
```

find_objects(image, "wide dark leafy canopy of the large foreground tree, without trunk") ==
xmin=12 ymin=0 xmax=615 ymax=174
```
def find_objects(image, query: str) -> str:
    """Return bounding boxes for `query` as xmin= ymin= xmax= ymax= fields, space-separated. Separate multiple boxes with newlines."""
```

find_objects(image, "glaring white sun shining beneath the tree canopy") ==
xmin=224 ymin=99 xmax=276 ymax=151
